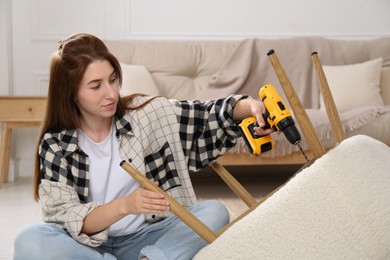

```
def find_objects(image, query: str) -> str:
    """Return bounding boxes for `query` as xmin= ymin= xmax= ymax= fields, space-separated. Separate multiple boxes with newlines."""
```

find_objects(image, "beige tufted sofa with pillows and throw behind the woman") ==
xmin=105 ymin=37 xmax=390 ymax=165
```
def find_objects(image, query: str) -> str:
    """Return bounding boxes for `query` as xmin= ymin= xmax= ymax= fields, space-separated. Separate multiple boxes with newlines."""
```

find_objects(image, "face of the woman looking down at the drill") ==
xmin=76 ymin=60 xmax=120 ymax=124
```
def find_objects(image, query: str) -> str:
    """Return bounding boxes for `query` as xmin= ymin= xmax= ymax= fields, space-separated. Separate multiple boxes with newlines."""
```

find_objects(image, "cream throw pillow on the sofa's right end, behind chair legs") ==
xmin=320 ymin=58 xmax=383 ymax=112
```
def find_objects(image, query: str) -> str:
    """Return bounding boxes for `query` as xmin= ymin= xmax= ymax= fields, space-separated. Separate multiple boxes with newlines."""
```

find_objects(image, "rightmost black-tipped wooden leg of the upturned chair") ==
xmin=311 ymin=52 xmax=346 ymax=143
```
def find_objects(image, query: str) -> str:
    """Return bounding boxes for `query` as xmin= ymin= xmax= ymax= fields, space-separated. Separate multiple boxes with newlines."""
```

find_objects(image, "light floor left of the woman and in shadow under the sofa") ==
xmin=0 ymin=166 xmax=297 ymax=260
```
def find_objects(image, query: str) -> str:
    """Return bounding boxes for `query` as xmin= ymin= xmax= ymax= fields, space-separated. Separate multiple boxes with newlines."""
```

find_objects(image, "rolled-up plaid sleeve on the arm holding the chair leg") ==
xmin=39 ymin=134 xmax=108 ymax=247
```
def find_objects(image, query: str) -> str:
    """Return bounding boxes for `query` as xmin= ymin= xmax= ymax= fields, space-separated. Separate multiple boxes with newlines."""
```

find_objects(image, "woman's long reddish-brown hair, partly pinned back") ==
xmin=34 ymin=33 xmax=155 ymax=201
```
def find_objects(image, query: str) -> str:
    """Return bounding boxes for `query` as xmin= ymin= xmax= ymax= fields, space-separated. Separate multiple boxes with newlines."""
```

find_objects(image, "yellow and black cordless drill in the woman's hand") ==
xmin=239 ymin=84 xmax=306 ymax=158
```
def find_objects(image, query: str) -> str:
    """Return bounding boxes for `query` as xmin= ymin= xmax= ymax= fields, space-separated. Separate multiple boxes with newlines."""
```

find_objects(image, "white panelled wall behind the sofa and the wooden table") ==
xmin=0 ymin=0 xmax=390 ymax=179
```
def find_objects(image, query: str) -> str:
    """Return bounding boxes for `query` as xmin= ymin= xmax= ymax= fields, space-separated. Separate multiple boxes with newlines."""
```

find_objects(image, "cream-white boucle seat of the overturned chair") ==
xmin=194 ymin=135 xmax=390 ymax=260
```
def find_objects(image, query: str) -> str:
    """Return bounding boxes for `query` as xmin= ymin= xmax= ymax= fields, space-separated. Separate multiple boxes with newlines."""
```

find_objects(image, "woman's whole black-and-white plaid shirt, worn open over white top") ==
xmin=39 ymin=95 xmax=246 ymax=246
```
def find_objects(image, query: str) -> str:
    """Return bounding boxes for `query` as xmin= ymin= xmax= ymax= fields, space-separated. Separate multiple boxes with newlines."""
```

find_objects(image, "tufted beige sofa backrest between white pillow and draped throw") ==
xmin=105 ymin=40 xmax=239 ymax=100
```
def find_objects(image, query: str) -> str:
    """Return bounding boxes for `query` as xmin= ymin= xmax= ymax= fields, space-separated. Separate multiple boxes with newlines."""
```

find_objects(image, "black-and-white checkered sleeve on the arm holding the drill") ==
xmin=176 ymin=95 xmax=248 ymax=171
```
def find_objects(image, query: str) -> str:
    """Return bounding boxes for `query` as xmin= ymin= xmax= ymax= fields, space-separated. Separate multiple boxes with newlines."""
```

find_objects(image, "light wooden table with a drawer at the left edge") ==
xmin=0 ymin=96 xmax=46 ymax=188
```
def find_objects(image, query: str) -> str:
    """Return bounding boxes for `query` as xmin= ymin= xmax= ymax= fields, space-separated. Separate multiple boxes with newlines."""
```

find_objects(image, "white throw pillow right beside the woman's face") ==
xmin=120 ymin=63 xmax=159 ymax=96
